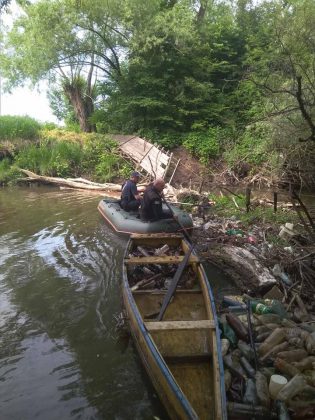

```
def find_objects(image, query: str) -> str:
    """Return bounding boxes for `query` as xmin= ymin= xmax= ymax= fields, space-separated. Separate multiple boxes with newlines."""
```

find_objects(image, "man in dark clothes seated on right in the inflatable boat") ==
xmin=140 ymin=178 xmax=172 ymax=222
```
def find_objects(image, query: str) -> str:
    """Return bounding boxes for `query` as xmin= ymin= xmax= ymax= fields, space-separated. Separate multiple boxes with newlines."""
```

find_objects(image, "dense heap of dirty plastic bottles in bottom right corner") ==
xmin=219 ymin=295 xmax=315 ymax=419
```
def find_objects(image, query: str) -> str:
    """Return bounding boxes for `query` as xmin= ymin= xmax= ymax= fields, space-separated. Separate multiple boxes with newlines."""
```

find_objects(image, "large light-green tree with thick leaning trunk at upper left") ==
xmin=0 ymin=0 xmax=125 ymax=131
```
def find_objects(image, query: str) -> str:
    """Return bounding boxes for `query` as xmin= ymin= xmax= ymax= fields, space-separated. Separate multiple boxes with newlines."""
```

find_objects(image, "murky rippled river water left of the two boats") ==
xmin=0 ymin=187 xmax=166 ymax=420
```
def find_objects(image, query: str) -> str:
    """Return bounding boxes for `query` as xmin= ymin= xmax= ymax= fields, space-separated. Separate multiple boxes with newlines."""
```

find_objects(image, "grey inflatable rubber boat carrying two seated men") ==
xmin=98 ymin=199 xmax=193 ymax=234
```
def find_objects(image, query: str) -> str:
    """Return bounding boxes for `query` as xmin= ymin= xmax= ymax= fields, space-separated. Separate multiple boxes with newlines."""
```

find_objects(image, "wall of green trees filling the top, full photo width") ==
xmin=0 ymin=0 xmax=315 ymax=184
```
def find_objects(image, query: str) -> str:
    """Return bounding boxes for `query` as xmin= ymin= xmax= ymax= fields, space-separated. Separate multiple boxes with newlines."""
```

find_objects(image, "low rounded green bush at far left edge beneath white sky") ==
xmin=0 ymin=115 xmax=41 ymax=140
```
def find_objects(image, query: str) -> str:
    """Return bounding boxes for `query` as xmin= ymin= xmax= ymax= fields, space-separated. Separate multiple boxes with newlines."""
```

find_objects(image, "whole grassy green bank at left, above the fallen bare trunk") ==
xmin=0 ymin=116 xmax=132 ymax=185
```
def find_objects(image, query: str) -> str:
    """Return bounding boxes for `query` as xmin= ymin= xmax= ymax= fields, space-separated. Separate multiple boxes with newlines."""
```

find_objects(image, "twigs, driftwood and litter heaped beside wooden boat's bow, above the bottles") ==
xmin=189 ymin=196 xmax=315 ymax=303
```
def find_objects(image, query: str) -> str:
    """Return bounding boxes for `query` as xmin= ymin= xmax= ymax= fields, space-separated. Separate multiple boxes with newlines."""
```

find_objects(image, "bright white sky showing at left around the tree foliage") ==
xmin=0 ymin=1 xmax=58 ymax=123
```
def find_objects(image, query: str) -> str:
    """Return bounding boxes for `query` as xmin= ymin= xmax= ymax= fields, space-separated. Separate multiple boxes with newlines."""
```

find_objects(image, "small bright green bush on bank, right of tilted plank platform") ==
xmin=183 ymin=127 xmax=227 ymax=164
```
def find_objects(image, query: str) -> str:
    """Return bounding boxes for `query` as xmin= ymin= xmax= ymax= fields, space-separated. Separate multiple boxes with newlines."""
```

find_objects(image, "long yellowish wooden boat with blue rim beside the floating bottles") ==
xmin=123 ymin=234 xmax=227 ymax=420
